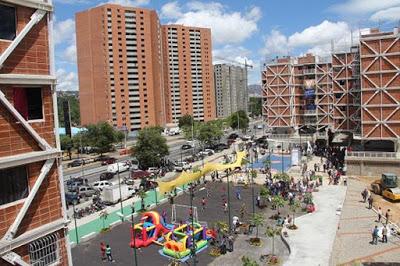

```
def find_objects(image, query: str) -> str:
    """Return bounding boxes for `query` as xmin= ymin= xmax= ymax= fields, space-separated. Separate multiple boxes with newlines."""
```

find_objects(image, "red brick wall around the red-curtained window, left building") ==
xmin=0 ymin=85 xmax=55 ymax=157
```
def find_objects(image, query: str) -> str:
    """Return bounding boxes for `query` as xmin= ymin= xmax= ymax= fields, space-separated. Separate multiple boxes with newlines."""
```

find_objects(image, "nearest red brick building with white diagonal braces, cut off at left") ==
xmin=0 ymin=0 xmax=72 ymax=265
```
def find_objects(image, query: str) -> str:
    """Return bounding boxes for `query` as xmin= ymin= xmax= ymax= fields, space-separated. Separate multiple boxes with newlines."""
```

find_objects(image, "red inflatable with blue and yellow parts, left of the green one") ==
xmin=130 ymin=211 xmax=174 ymax=248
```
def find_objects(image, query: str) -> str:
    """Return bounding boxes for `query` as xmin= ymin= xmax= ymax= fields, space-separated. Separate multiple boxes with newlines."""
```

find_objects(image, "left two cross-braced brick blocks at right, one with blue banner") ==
xmin=262 ymin=54 xmax=334 ymax=133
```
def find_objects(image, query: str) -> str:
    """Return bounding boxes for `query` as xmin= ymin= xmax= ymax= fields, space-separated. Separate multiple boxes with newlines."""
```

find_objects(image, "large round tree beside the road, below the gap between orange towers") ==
xmin=131 ymin=127 xmax=169 ymax=169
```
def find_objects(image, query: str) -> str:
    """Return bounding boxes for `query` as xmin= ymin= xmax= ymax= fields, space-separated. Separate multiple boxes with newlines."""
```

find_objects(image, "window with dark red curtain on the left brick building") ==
xmin=14 ymin=88 xmax=43 ymax=120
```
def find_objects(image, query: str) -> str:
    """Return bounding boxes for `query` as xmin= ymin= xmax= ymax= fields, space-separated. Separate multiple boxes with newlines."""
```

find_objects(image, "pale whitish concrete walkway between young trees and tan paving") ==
xmin=284 ymin=185 xmax=346 ymax=266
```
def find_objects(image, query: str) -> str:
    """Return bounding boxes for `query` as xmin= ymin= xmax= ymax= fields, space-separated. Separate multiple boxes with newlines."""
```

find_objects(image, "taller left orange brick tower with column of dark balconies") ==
xmin=76 ymin=4 xmax=165 ymax=131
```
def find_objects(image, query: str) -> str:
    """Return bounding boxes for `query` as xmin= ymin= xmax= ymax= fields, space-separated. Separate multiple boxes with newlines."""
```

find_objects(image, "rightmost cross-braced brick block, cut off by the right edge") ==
xmin=360 ymin=28 xmax=400 ymax=141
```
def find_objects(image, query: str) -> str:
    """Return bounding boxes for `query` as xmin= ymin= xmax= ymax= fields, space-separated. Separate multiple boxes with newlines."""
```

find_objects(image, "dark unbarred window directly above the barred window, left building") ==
xmin=0 ymin=166 xmax=29 ymax=205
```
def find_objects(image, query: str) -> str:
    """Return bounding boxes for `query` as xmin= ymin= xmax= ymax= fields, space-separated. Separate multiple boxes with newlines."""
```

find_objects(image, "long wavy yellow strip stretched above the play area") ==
xmin=157 ymin=151 xmax=246 ymax=194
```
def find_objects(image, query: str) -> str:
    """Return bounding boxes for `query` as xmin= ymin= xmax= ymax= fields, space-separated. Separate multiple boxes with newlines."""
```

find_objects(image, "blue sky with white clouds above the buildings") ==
xmin=53 ymin=0 xmax=400 ymax=90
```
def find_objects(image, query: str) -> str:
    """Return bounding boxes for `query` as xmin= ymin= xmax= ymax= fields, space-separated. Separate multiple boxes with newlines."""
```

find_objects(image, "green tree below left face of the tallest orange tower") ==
xmin=83 ymin=122 xmax=124 ymax=154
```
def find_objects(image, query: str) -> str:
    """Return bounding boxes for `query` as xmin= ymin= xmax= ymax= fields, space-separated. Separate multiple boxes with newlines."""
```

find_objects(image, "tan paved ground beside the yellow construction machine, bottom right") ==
xmin=330 ymin=179 xmax=400 ymax=265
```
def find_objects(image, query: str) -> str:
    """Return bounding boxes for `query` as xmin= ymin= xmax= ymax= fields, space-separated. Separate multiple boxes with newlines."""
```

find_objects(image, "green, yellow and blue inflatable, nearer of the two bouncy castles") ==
xmin=162 ymin=222 xmax=215 ymax=260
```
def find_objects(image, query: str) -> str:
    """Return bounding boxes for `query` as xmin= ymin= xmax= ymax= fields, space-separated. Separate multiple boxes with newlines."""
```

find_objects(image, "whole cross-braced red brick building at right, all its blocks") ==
xmin=262 ymin=28 xmax=400 ymax=150
